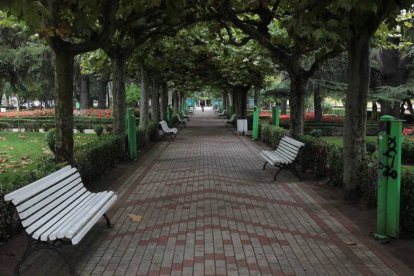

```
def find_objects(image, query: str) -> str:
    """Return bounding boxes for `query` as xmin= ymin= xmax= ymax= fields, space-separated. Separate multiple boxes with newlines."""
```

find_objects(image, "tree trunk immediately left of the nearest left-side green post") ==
xmin=112 ymin=54 xmax=126 ymax=154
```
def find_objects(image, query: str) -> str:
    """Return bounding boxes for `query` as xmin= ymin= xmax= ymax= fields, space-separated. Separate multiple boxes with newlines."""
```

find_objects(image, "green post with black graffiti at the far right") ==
xmin=375 ymin=115 xmax=402 ymax=239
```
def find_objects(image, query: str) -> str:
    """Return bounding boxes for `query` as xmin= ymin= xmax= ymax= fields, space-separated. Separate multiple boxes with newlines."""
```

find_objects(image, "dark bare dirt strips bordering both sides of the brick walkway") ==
xmin=0 ymin=157 xmax=414 ymax=275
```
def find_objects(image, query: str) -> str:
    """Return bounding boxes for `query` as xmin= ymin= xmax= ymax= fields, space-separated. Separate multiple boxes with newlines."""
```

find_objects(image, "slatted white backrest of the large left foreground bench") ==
xmin=4 ymin=166 xmax=87 ymax=231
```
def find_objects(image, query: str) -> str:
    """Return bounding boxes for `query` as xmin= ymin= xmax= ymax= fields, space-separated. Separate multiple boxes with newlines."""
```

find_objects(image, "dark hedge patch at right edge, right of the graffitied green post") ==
xmin=400 ymin=170 xmax=414 ymax=234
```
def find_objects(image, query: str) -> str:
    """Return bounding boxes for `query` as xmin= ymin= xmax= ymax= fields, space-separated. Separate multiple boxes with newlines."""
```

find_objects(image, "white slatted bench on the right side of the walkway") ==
xmin=260 ymin=136 xmax=305 ymax=180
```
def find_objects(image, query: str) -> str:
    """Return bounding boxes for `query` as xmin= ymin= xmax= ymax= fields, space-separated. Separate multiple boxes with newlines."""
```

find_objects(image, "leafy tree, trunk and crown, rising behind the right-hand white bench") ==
xmin=207 ymin=0 xmax=343 ymax=136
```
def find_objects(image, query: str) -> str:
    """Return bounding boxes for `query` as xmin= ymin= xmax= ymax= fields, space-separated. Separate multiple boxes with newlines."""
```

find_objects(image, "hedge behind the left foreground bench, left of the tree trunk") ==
xmin=0 ymin=158 xmax=63 ymax=241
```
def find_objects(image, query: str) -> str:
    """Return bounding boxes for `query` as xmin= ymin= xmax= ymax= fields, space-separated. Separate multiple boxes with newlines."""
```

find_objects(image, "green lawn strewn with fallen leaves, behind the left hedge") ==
xmin=0 ymin=131 xmax=97 ymax=184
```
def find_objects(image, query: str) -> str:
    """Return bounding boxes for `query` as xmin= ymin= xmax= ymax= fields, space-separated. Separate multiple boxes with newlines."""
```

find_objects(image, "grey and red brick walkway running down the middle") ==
xmin=22 ymin=106 xmax=411 ymax=275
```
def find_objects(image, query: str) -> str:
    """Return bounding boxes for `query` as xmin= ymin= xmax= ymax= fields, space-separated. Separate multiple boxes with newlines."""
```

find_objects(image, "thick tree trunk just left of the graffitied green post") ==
xmin=343 ymin=33 xmax=370 ymax=201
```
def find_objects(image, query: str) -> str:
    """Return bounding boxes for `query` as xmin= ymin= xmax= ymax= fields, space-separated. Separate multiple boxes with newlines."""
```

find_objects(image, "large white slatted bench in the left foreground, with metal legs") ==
xmin=4 ymin=166 xmax=117 ymax=274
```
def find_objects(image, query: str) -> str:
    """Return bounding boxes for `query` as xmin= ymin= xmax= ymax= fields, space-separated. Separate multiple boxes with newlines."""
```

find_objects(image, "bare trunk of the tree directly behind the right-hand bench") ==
xmin=289 ymin=73 xmax=308 ymax=137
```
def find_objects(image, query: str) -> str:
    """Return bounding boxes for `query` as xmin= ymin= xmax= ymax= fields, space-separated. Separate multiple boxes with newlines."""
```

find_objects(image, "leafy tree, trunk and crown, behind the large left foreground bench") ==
xmin=0 ymin=0 xmax=118 ymax=163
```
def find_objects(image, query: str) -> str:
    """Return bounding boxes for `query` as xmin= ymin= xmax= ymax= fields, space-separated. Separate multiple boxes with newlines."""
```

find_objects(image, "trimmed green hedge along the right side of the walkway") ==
xmin=261 ymin=124 xmax=414 ymax=234
